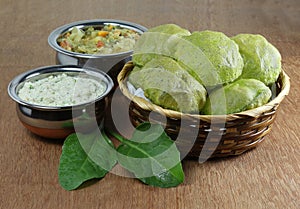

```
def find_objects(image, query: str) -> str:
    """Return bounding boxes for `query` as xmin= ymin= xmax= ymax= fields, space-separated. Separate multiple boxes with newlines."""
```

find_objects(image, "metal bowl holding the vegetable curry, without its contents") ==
xmin=48 ymin=19 xmax=147 ymax=73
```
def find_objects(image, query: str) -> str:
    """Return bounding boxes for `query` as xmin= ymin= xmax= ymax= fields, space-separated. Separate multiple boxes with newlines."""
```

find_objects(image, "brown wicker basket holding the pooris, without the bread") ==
xmin=118 ymin=62 xmax=290 ymax=161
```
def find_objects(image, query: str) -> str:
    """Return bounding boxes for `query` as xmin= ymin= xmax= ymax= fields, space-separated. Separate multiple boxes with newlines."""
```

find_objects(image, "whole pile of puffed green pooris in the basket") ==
xmin=129 ymin=24 xmax=281 ymax=115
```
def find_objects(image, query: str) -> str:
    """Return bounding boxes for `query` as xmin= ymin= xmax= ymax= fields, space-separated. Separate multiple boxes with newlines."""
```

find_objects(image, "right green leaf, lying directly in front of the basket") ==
xmin=115 ymin=123 xmax=184 ymax=187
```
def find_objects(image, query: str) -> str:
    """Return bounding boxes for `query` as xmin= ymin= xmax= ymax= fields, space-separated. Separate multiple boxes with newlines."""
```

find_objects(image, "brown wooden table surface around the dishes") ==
xmin=0 ymin=0 xmax=300 ymax=209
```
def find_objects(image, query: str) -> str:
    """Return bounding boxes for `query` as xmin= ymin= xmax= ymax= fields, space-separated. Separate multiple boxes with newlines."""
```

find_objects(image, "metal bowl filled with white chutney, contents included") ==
xmin=8 ymin=65 xmax=114 ymax=139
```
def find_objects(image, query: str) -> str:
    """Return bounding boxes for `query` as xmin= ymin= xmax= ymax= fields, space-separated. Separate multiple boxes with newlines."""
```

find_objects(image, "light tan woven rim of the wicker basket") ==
xmin=117 ymin=61 xmax=290 ymax=121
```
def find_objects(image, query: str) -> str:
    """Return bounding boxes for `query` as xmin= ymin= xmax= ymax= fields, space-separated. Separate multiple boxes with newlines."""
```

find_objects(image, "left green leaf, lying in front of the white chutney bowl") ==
xmin=58 ymin=129 xmax=117 ymax=190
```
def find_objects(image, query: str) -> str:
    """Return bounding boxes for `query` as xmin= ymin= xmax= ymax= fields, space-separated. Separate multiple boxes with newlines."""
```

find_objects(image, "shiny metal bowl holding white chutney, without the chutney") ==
xmin=8 ymin=65 xmax=114 ymax=138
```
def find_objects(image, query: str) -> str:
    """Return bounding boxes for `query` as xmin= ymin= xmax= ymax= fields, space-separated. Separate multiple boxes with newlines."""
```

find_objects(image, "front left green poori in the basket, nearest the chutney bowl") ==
xmin=129 ymin=56 xmax=206 ymax=113
